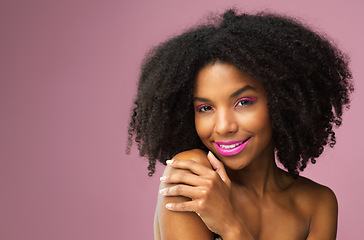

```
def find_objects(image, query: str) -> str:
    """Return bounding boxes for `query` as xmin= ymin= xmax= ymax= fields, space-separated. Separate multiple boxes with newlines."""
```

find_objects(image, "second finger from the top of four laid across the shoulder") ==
xmin=160 ymin=171 xmax=206 ymax=186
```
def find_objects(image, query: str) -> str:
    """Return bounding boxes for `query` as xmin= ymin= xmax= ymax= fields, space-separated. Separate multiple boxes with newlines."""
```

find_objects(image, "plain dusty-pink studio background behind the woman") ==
xmin=0 ymin=0 xmax=364 ymax=240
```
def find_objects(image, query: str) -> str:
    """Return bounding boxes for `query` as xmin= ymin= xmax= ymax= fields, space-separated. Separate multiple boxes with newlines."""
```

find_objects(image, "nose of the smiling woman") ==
xmin=215 ymin=110 xmax=238 ymax=135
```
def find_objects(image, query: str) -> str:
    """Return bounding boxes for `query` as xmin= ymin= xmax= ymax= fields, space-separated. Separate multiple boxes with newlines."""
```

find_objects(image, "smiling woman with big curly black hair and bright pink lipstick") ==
xmin=129 ymin=10 xmax=353 ymax=240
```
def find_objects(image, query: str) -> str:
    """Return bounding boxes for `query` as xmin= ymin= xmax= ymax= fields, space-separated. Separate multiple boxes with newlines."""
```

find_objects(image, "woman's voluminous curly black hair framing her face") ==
xmin=127 ymin=10 xmax=354 ymax=177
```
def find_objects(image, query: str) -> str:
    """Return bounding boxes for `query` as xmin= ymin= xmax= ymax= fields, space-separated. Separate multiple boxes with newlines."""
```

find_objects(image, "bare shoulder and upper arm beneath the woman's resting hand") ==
xmin=154 ymin=149 xmax=212 ymax=240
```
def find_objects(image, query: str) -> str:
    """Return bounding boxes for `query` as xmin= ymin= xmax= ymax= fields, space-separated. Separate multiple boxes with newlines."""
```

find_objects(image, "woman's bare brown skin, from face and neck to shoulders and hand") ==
xmin=154 ymin=63 xmax=338 ymax=240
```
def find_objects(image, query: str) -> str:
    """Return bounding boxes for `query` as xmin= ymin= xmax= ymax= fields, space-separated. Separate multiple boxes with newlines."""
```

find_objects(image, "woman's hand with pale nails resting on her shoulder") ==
xmin=161 ymin=152 xmax=239 ymax=237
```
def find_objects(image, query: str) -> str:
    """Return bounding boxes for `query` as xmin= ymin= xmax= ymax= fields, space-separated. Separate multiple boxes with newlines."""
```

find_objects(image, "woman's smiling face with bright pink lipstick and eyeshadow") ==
xmin=194 ymin=63 xmax=273 ymax=170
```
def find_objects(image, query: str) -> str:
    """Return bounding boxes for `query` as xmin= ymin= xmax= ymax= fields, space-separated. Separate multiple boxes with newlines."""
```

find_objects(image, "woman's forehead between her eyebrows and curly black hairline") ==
xmin=194 ymin=63 xmax=265 ymax=96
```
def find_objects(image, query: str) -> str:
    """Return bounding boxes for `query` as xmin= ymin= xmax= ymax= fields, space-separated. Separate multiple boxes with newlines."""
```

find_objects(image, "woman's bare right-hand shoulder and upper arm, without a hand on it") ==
xmin=293 ymin=177 xmax=338 ymax=240
